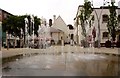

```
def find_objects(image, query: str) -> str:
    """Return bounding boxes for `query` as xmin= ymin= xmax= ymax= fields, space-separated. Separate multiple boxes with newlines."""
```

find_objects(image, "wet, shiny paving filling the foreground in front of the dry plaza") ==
xmin=3 ymin=52 xmax=118 ymax=76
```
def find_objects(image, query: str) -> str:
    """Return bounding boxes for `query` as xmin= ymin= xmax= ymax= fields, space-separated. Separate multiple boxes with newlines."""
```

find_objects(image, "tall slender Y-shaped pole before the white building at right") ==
xmin=92 ymin=0 xmax=109 ymax=48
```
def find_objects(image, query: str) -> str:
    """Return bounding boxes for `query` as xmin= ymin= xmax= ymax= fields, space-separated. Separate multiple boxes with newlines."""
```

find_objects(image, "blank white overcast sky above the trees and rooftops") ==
xmin=0 ymin=0 xmax=120 ymax=25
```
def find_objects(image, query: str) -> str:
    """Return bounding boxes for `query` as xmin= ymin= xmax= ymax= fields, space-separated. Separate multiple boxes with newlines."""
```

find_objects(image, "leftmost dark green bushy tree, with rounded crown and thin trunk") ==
xmin=3 ymin=16 xmax=20 ymax=48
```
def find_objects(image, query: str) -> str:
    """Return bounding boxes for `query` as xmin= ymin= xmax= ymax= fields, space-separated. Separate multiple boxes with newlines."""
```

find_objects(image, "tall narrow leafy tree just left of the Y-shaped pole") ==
xmin=79 ymin=1 xmax=93 ymax=47
